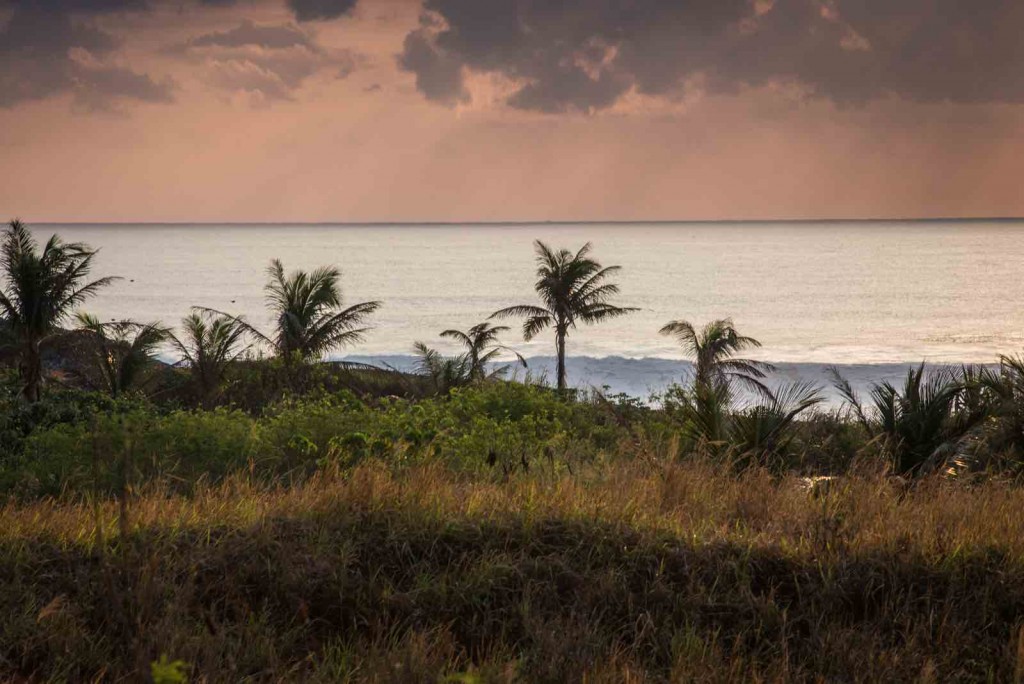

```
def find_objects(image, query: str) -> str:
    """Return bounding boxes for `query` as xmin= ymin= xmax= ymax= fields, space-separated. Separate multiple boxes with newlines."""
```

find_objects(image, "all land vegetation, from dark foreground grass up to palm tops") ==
xmin=9 ymin=224 xmax=1024 ymax=682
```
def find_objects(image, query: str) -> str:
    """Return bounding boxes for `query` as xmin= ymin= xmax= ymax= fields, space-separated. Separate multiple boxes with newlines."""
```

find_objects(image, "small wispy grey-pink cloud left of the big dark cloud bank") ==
xmin=169 ymin=19 xmax=357 ymax=103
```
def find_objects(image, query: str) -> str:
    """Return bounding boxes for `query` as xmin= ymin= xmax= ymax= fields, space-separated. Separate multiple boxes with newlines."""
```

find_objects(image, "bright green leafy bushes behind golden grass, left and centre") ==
xmin=0 ymin=383 xmax=624 ymax=497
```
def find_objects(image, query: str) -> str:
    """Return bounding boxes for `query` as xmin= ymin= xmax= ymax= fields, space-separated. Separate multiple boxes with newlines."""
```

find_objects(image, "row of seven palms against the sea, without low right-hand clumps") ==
xmin=0 ymin=220 xmax=770 ymax=403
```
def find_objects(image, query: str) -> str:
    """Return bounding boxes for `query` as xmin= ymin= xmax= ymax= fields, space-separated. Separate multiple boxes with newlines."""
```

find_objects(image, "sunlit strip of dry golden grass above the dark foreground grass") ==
xmin=0 ymin=461 xmax=1024 ymax=559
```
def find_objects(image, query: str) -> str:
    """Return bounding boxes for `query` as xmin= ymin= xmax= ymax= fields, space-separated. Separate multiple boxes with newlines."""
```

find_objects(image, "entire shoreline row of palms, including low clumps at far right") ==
xmin=9 ymin=220 xmax=1024 ymax=473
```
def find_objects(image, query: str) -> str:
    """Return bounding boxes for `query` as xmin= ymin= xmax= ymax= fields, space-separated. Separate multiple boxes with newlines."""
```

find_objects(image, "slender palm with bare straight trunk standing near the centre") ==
xmin=490 ymin=240 xmax=637 ymax=390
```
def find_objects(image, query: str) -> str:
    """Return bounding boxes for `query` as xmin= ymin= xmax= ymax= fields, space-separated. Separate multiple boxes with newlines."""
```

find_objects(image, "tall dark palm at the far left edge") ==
xmin=0 ymin=220 xmax=115 ymax=402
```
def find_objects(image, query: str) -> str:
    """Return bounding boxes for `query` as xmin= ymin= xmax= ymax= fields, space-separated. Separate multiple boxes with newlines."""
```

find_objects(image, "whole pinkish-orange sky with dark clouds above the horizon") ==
xmin=0 ymin=0 xmax=1024 ymax=222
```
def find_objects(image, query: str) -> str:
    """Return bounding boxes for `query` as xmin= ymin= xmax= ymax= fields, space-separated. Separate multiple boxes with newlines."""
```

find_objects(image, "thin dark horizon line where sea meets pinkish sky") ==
xmin=26 ymin=216 xmax=1024 ymax=227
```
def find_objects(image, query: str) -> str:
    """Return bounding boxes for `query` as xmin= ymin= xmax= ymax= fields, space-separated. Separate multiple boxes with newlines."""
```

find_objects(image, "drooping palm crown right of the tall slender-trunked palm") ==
xmin=659 ymin=318 xmax=774 ymax=399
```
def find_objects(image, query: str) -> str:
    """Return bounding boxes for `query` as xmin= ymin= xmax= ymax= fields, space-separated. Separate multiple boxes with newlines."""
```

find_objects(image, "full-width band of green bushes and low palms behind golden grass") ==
xmin=9 ymin=359 xmax=1024 ymax=498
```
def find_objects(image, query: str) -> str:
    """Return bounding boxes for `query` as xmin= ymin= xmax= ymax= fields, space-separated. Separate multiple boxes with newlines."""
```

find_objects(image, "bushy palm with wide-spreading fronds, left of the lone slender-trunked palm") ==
xmin=203 ymin=259 xmax=381 ymax=364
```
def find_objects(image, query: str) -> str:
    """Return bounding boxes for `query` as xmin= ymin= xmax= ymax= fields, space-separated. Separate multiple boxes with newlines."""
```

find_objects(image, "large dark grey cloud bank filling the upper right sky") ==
xmin=399 ymin=0 xmax=1024 ymax=112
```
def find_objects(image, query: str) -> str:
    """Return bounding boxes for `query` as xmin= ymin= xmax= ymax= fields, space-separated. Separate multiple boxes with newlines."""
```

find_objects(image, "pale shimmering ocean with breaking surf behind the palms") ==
xmin=32 ymin=220 xmax=1024 ymax=396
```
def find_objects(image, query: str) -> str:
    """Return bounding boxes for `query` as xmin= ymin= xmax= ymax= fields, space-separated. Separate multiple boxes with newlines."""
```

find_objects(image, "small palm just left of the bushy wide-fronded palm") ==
xmin=171 ymin=311 xmax=249 ymax=407
